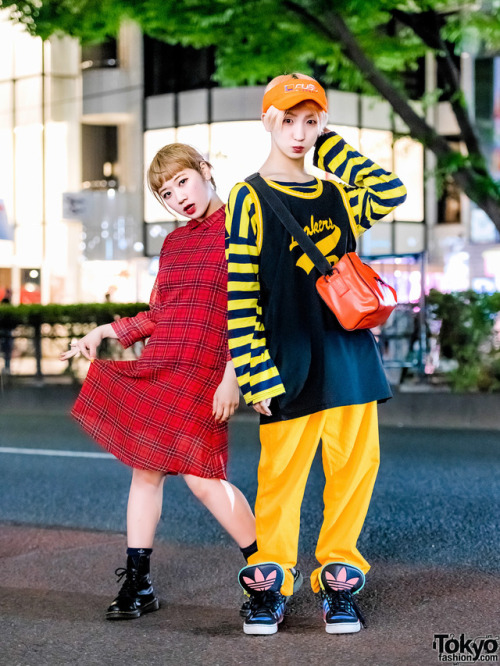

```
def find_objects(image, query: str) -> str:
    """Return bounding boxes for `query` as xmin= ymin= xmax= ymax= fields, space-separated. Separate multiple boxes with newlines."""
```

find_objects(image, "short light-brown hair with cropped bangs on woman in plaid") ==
xmin=146 ymin=143 xmax=215 ymax=206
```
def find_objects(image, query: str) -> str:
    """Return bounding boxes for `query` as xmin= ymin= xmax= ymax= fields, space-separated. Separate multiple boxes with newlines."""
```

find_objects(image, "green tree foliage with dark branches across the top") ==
xmin=0 ymin=0 xmax=500 ymax=229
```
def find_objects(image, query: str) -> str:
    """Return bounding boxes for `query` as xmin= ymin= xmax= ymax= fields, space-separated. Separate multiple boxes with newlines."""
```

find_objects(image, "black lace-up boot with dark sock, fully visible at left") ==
xmin=106 ymin=555 xmax=160 ymax=620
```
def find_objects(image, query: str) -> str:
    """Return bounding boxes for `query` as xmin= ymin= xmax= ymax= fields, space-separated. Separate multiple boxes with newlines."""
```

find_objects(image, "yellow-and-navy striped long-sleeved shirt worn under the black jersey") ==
xmin=226 ymin=127 xmax=406 ymax=404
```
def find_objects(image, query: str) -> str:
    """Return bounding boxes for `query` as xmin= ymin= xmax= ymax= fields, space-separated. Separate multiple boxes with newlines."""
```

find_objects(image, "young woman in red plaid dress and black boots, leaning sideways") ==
xmin=61 ymin=144 xmax=256 ymax=620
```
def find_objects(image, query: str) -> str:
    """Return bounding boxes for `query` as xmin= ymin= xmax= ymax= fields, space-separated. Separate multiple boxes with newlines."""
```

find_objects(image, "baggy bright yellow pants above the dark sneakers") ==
xmin=248 ymin=402 xmax=379 ymax=596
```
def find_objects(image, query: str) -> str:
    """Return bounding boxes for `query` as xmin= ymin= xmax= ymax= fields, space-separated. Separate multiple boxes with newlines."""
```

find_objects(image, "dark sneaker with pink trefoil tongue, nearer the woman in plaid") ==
xmin=238 ymin=562 xmax=287 ymax=635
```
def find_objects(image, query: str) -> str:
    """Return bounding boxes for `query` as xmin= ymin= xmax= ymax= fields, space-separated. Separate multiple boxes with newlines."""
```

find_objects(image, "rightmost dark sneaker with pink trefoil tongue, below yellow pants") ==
xmin=319 ymin=562 xmax=366 ymax=634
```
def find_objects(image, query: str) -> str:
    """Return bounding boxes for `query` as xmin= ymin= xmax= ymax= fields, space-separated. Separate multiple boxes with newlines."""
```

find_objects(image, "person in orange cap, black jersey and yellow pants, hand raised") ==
xmin=226 ymin=74 xmax=406 ymax=634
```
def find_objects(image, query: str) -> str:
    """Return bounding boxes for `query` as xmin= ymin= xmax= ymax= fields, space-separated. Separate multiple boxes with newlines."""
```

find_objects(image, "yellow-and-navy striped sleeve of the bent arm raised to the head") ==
xmin=314 ymin=132 xmax=406 ymax=237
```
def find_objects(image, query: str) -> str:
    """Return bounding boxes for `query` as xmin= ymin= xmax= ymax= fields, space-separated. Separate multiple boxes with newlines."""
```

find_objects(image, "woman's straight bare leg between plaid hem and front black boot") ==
xmin=127 ymin=469 xmax=165 ymax=548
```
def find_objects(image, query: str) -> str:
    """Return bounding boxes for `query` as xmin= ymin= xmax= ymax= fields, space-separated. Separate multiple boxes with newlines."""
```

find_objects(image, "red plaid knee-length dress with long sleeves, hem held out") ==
xmin=72 ymin=207 xmax=229 ymax=479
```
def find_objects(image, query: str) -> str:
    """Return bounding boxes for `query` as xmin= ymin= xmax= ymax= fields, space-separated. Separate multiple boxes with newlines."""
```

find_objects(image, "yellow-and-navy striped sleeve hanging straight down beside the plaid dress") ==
xmin=226 ymin=183 xmax=285 ymax=404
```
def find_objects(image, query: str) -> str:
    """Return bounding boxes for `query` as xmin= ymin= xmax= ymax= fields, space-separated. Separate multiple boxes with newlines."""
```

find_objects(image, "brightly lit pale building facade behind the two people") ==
xmin=0 ymin=14 xmax=500 ymax=303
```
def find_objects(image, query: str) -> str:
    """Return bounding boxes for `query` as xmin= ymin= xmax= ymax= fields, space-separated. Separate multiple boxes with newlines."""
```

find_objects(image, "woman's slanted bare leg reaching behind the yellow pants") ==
xmin=184 ymin=474 xmax=255 ymax=548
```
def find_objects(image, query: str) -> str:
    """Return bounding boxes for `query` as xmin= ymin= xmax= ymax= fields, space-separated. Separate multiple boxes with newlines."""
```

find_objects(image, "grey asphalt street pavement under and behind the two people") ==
xmin=0 ymin=386 xmax=500 ymax=666
